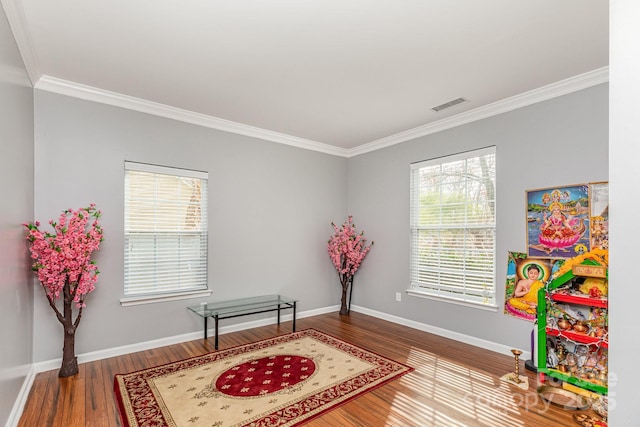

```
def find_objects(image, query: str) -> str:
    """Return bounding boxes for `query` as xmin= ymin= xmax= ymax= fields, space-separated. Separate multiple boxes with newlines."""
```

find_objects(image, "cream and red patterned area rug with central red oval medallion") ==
xmin=114 ymin=329 xmax=413 ymax=427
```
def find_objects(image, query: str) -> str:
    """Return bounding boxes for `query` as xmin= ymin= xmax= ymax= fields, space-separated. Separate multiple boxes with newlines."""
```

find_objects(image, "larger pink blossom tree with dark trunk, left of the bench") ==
xmin=24 ymin=204 xmax=102 ymax=377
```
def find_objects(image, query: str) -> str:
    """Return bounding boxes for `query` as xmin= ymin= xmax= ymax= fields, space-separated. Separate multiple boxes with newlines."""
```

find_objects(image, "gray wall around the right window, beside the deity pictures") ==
xmin=348 ymin=85 xmax=608 ymax=349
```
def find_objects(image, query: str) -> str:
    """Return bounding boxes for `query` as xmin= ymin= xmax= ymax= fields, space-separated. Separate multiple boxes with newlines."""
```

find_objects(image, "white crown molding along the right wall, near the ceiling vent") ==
xmin=347 ymin=67 xmax=609 ymax=157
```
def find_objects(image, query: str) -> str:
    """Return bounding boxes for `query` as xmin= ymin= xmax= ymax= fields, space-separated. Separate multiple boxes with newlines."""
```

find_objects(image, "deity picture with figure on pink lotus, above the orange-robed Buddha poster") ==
xmin=526 ymin=184 xmax=591 ymax=258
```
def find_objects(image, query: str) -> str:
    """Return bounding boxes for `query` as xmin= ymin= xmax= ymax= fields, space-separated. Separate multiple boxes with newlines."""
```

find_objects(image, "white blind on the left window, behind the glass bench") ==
xmin=124 ymin=162 xmax=208 ymax=296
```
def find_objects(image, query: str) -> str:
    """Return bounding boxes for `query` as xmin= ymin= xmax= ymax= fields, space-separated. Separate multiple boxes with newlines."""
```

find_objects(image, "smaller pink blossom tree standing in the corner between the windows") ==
xmin=327 ymin=215 xmax=373 ymax=314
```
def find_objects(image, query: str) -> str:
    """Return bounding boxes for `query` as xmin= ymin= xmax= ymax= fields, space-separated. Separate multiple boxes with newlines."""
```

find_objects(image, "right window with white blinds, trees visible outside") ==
xmin=408 ymin=147 xmax=496 ymax=308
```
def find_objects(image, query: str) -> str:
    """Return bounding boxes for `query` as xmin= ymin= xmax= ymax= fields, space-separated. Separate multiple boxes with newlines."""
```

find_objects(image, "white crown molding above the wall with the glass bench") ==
xmin=35 ymin=75 xmax=348 ymax=157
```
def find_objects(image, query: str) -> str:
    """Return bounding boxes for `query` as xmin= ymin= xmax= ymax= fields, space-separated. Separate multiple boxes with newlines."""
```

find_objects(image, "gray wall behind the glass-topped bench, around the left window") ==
xmin=34 ymin=90 xmax=347 ymax=362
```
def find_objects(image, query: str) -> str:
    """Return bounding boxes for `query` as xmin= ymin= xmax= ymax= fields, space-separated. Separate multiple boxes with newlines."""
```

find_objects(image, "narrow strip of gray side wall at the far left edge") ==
xmin=0 ymin=7 xmax=33 ymax=425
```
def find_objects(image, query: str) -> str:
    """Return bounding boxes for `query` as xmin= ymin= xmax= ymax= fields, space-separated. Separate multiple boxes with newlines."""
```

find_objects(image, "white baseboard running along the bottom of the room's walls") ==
xmin=6 ymin=305 xmax=531 ymax=427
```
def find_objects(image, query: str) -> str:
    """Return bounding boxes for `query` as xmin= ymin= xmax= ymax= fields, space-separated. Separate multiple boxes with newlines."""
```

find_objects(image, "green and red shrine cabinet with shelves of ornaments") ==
xmin=537 ymin=259 xmax=609 ymax=395
